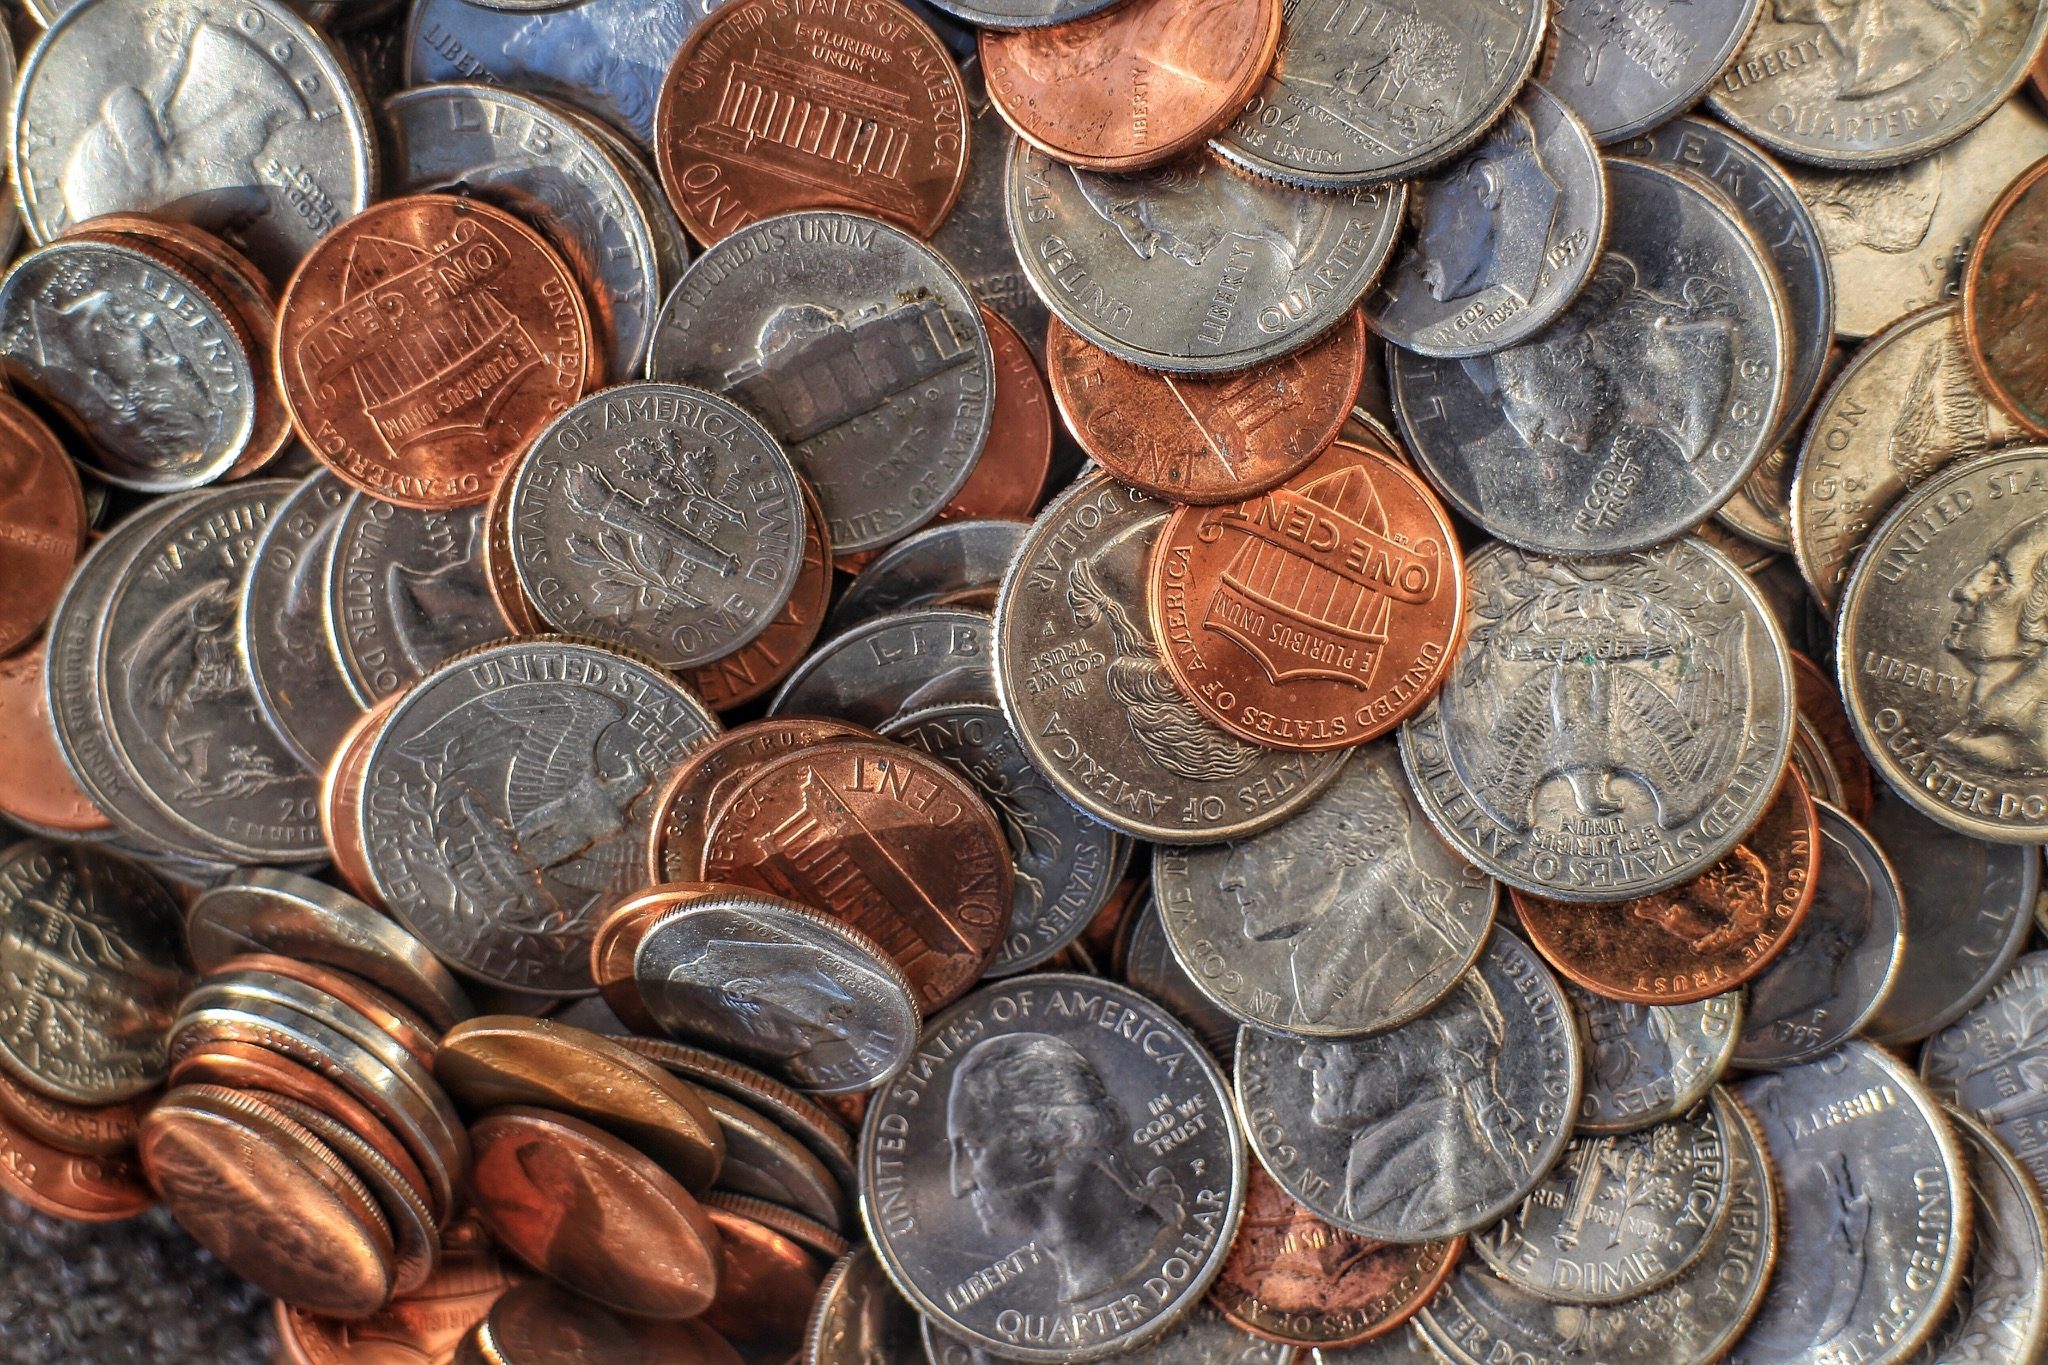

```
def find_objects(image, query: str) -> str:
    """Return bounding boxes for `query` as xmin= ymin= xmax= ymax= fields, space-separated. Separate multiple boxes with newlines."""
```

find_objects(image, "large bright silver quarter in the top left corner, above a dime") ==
xmin=10 ymin=0 xmax=377 ymax=280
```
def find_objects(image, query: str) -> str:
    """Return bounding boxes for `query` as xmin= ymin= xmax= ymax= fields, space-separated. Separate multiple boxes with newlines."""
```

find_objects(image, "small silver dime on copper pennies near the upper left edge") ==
xmin=0 ymin=241 xmax=268 ymax=493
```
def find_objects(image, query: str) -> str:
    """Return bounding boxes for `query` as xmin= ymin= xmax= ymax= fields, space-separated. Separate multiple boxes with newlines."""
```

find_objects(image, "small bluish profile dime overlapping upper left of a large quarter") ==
xmin=1366 ymin=82 xmax=1608 ymax=356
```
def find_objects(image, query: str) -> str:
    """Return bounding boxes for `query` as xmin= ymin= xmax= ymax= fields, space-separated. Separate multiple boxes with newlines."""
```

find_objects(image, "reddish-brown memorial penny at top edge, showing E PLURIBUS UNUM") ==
xmin=653 ymin=0 xmax=967 ymax=244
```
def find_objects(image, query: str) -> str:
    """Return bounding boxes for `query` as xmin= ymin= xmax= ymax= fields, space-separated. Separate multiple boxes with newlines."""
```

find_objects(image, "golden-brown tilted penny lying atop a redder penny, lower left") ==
xmin=434 ymin=1015 xmax=725 ymax=1193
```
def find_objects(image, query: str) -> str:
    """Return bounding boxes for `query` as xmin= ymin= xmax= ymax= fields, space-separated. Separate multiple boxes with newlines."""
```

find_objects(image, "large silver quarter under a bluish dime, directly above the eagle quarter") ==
xmin=1389 ymin=158 xmax=1792 ymax=555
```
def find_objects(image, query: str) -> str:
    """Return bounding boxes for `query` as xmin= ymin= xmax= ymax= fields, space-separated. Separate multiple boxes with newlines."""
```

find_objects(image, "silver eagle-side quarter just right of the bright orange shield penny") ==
xmin=1401 ymin=536 xmax=1794 ymax=900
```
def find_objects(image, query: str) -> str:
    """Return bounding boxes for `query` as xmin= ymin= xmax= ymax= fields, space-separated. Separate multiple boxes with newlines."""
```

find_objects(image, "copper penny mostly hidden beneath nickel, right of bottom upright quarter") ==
xmin=1208 ymin=1162 xmax=1464 ymax=1347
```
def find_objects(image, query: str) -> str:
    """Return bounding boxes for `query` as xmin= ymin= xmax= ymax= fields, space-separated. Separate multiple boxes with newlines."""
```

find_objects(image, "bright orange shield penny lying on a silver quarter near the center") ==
xmin=1145 ymin=442 xmax=1464 ymax=749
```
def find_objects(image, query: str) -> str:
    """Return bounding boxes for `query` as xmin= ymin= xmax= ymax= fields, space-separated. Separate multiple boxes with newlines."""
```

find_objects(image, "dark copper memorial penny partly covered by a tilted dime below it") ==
xmin=702 ymin=741 xmax=1014 ymax=1013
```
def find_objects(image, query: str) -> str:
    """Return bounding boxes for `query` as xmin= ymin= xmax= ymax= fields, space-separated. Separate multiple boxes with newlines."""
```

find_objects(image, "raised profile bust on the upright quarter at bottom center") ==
xmin=946 ymin=1033 xmax=1186 ymax=1308
